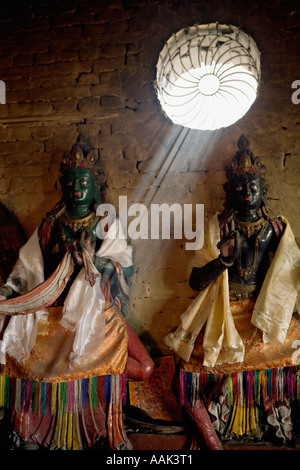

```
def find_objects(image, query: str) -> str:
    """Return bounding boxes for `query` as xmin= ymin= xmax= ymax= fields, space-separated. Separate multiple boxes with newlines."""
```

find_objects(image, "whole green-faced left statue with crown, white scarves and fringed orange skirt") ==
xmin=0 ymin=136 xmax=154 ymax=450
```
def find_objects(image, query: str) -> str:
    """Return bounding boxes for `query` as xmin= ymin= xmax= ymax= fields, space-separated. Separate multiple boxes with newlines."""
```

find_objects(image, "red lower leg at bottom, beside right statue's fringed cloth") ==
xmin=184 ymin=403 xmax=223 ymax=450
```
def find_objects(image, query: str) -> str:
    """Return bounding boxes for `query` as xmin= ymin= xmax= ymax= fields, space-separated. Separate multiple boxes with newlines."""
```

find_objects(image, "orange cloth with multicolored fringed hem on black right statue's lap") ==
xmin=181 ymin=299 xmax=300 ymax=439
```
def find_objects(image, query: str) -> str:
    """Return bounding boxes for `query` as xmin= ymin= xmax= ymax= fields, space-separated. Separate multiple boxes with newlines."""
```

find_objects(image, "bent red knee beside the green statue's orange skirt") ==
xmin=127 ymin=324 xmax=154 ymax=380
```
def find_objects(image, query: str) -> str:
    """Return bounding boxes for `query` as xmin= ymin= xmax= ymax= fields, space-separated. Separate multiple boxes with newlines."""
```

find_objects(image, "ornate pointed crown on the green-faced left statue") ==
xmin=60 ymin=134 xmax=106 ymax=183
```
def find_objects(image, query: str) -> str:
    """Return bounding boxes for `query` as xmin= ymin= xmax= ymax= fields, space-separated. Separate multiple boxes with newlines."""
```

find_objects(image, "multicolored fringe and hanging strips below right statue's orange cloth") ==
xmin=180 ymin=366 xmax=300 ymax=439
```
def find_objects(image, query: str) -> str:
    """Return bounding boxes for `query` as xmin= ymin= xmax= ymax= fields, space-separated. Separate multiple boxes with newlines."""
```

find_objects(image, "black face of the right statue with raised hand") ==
xmin=232 ymin=173 xmax=263 ymax=210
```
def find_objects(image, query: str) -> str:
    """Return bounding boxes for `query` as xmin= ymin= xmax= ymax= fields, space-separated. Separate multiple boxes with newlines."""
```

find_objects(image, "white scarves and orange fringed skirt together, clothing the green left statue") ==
xmin=0 ymin=216 xmax=132 ymax=450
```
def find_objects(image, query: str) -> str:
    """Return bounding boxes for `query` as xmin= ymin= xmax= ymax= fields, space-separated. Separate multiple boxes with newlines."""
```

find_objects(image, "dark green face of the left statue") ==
xmin=62 ymin=167 xmax=95 ymax=207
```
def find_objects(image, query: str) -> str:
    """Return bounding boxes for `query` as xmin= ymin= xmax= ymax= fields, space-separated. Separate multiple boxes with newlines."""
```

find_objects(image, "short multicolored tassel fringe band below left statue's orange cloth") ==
xmin=0 ymin=374 xmax=126 ymax=416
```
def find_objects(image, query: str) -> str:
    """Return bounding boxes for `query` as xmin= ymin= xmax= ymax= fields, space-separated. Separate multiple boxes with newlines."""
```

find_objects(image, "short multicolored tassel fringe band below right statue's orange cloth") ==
xmin=180 ymin=366 xmax=300 ymax=406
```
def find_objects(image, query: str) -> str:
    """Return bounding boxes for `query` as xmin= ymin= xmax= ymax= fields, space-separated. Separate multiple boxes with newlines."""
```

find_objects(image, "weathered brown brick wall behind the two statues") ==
xmin=0 ymin=0 xmax=300 ymax=352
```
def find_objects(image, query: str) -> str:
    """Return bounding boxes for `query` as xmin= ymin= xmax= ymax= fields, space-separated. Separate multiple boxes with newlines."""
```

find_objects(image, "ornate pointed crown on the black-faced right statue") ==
xmin=226 ymin=135 xmax=266 ymax=180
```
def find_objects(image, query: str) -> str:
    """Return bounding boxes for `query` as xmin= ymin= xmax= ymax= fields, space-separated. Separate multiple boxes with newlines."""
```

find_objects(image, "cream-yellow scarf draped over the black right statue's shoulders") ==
xmin=164 ymin=214 xmax=300 ymax=367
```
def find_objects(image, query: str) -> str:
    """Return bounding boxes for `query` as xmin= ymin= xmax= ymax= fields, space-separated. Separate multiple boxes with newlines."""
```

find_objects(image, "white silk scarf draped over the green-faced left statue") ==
xmin=0 ymin=219 xmax=132 ymax=364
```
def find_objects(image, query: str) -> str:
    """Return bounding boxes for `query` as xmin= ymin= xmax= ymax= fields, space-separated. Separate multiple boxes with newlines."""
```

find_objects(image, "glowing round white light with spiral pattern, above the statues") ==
xmin=156 ymin=23 xmax=260 ymax=130
